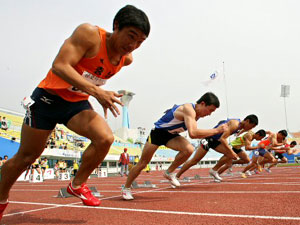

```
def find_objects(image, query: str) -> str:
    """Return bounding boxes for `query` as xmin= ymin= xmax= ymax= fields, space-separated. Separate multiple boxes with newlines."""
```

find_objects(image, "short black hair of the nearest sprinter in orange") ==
xmin=113 ymin=5 xmax=150 ymax=37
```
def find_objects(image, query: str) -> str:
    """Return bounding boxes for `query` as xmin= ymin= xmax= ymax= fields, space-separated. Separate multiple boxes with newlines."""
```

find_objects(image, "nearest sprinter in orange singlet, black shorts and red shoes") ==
xmin=0 ymin=5 xmax=150 ymax=219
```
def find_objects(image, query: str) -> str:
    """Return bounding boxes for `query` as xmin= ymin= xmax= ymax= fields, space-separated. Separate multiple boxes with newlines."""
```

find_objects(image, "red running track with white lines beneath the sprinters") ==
xmin=1 ymin=167 xmax=300 ymax=225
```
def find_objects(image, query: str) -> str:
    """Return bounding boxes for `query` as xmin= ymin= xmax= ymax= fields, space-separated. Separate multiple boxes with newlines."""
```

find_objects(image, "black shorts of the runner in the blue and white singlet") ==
xmin=147 ymin=128 xmax=180 ymax=146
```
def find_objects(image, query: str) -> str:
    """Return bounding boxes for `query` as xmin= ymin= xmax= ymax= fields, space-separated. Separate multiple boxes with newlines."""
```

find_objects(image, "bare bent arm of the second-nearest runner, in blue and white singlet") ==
xmin=179 ymin=104 xmax=226 ymax=139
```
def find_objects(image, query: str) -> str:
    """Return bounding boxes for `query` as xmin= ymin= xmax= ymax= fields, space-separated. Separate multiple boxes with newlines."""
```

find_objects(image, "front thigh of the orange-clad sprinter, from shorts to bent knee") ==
xmin=67 ymin=110 xmax=112 ymax=141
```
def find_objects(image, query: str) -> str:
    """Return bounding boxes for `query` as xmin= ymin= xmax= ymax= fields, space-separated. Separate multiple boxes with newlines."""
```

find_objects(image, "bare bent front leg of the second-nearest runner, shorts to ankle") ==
xmin=166 ymin=136 xmax=194 ymax=173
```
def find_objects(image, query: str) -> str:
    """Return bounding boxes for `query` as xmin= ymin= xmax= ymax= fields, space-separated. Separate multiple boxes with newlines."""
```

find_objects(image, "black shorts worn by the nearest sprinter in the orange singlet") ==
xmin=24 ymin=88 xmax=92 ymax=130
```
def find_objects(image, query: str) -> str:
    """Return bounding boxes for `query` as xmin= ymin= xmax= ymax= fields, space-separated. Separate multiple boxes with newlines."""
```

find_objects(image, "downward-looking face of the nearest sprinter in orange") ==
xmin=114 ymin=27 xmax=147 ymax=55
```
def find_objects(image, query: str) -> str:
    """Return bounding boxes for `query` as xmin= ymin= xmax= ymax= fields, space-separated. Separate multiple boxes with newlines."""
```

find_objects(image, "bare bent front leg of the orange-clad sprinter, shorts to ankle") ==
xmin=67 ymin=110 xmax=114 ymax=189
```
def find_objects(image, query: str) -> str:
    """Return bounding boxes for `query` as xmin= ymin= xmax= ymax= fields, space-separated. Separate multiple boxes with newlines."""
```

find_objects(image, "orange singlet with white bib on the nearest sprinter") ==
xmin=38 ymin=27 xmax=125 ymax=102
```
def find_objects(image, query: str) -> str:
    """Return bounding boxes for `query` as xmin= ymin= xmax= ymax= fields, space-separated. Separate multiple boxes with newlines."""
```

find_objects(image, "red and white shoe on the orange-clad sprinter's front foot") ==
xmin=67 ymin=182 xmax=101 ymax=206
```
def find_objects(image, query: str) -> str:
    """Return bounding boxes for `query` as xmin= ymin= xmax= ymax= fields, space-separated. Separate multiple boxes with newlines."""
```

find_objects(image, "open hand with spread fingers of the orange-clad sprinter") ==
xmin=95 ymin=90 xmax=123 ymax=119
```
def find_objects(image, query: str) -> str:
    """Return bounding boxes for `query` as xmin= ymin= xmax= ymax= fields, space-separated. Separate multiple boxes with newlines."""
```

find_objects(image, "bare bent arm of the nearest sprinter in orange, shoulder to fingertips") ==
xmin=52 ymin=24 xmax=122 ymax=117
